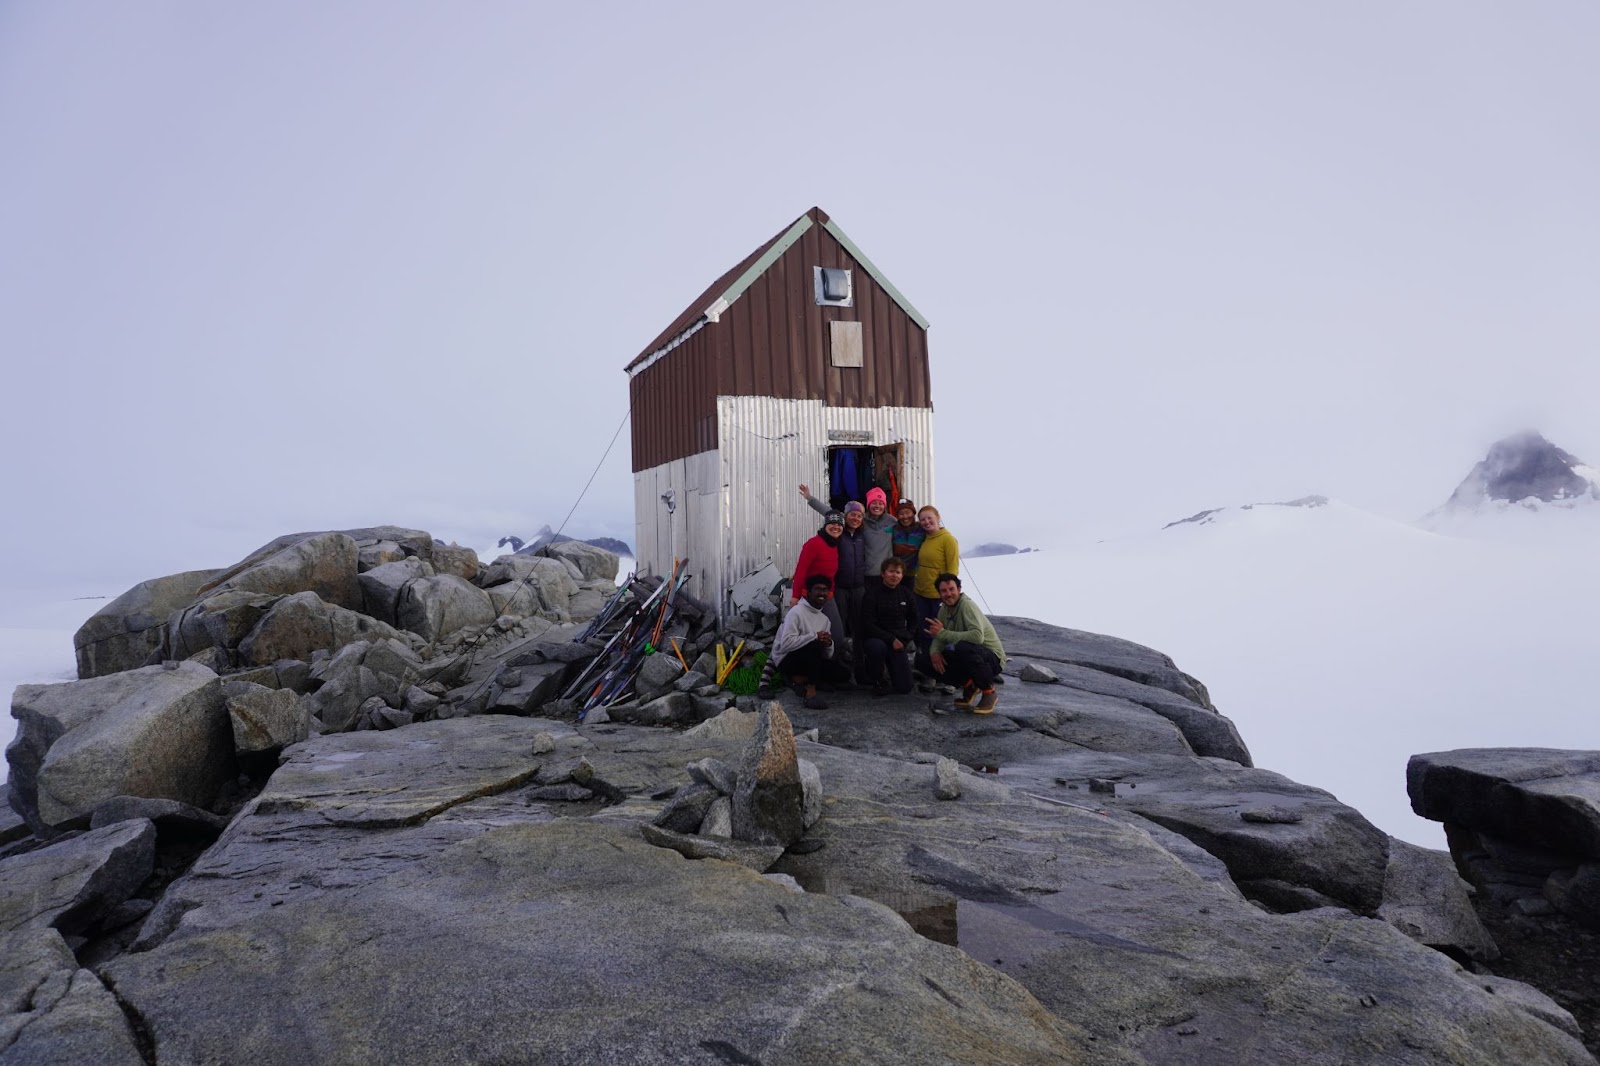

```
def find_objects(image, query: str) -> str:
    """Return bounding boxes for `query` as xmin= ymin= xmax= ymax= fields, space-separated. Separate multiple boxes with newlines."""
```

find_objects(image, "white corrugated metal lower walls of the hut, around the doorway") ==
xmin=634 ymin=395 xmax=934 ymax=610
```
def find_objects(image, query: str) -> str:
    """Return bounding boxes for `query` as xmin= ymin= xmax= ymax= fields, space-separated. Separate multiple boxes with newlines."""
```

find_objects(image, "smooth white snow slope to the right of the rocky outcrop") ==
xmin=966 ymin=501 xmax=1600 ymax=847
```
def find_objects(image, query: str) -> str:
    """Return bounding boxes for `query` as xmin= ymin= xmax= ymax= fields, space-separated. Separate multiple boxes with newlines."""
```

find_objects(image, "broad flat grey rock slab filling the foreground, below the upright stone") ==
xmin=81 ymin=713 xmax=1592 ymax=1066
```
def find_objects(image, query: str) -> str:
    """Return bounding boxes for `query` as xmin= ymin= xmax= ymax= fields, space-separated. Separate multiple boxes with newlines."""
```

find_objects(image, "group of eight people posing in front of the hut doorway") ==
xmin=768 ymin=485 xmax=1005 ymax=714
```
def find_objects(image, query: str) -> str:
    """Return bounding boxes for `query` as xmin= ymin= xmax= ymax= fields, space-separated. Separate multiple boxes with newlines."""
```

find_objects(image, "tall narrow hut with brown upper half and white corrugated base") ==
xmin=627 ymin=208 xmax=933 ymax=615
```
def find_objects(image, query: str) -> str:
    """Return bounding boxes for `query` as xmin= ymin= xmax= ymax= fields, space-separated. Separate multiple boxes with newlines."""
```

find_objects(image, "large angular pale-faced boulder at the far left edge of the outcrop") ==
xmin=6 ymin=663 xmax=234 ymax=836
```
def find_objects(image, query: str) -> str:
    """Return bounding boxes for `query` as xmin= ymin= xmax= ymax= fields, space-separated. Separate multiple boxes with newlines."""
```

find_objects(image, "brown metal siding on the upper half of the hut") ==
xmin=629 ymin=211 xmax=933 ymax=472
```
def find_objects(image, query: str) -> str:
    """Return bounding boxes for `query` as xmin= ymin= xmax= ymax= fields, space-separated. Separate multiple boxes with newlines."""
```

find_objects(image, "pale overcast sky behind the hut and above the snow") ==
xmin=0 ymin=0 xmax=1600 ymax=592
